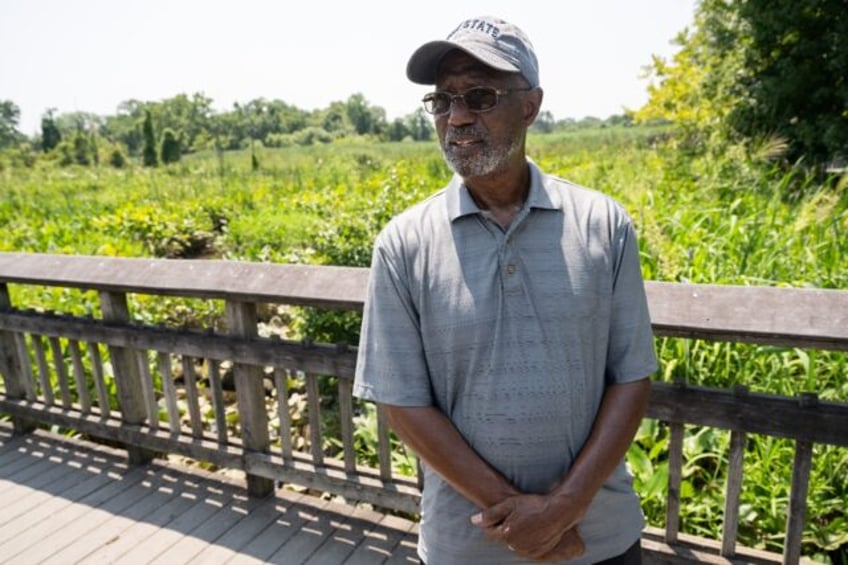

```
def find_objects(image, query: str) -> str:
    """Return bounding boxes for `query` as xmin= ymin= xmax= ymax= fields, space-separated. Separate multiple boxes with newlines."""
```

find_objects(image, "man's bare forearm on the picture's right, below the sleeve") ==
xmin=551 ymin=379 xmax=651 ymax=510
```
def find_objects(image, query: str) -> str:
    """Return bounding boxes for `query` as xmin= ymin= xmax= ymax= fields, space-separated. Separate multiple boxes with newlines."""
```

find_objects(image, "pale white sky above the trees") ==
xmin=0 ymin=0 xmax=697 ymax=135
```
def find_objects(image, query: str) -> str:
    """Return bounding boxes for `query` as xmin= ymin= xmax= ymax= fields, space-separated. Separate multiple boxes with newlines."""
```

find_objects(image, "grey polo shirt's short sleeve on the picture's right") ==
xmin=606 ymin=218 xmax=658 ymax=384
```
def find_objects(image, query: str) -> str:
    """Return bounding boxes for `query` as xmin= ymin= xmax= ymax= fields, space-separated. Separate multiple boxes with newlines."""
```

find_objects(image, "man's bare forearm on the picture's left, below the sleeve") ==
xmin=384 ymin=405 xmax=519 ymax=508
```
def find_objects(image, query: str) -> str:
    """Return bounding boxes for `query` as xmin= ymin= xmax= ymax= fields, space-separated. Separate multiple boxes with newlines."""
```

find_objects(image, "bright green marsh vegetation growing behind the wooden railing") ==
xmin=0 ymin=126 xmax=848 ymax=555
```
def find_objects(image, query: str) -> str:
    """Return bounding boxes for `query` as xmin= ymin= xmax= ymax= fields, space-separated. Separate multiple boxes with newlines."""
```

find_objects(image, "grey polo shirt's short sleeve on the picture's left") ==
xmin=353 ymin=224 xmax=433 ymax=406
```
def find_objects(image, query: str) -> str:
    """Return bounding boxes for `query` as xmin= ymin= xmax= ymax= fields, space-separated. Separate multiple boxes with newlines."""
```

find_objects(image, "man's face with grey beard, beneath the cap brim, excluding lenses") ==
xmin=435 ymin=51 xmax=527 ymax=179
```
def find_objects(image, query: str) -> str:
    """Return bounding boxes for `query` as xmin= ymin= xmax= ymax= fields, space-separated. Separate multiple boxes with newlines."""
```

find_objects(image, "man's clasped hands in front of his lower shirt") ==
xmin=471 ymin=494 xmax=585 ymax=561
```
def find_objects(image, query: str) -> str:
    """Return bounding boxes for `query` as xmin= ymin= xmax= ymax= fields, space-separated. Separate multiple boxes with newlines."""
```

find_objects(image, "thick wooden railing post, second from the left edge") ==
xmin=100 ymin=291 xmax=153 ymax=465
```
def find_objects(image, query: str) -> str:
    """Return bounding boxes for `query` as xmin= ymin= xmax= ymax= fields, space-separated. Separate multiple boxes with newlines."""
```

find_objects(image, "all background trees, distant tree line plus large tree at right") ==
xmin=0 ymin=0 xmax=848 ymax=170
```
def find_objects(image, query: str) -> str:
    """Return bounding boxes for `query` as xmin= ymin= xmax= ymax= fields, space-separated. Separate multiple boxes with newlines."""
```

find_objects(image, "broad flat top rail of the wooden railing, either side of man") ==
xmin=0 ymin=253 xmax=848 ymax=350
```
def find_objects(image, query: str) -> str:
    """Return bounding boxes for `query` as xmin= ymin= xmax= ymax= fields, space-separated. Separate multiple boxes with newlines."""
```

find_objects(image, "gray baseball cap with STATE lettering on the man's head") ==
xmin=406 ymin=16 xmax=539 ymax=87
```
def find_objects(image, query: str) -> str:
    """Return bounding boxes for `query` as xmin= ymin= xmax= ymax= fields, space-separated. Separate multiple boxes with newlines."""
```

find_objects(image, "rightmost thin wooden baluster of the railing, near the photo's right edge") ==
xmin=783 ymin=393 xmax=818 ymax=564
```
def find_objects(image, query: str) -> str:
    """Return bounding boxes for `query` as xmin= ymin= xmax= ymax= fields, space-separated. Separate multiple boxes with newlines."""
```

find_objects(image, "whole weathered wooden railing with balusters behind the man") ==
xmin=0 ymin=253 xmax=848 ymax=563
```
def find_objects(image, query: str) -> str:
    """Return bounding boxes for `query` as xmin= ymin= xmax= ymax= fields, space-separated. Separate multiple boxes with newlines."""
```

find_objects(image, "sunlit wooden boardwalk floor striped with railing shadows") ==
xmin=0 ymin=423 xmax=418 ymax=565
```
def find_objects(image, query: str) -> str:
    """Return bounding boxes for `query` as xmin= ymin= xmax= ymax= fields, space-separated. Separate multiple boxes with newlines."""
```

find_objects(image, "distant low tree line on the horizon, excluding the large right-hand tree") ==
xmin=0 ymin=93 xmax=630 ymax=167
